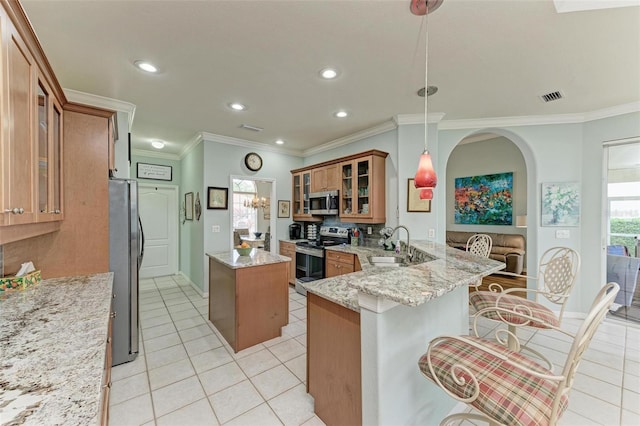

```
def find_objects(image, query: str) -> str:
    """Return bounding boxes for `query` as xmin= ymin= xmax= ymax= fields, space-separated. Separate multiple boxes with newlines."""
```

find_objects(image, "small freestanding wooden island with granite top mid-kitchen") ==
xmin=207 ymin=249 xmax=291 ymax=352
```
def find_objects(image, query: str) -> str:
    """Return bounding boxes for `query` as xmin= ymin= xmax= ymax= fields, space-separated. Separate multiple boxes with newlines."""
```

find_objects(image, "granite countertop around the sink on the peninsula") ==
xmin=303 ymin=241 xmax=505 ymax=311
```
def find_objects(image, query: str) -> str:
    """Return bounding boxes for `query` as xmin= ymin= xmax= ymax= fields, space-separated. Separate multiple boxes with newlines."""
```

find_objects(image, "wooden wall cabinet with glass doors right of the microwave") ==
xmin=340 ymin=151 xmax=387 ymax=223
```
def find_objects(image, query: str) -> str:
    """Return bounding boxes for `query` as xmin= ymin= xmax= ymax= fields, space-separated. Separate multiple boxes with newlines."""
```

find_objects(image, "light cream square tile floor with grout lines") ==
xmin=110 ymin=276 xmax=640 ymax=426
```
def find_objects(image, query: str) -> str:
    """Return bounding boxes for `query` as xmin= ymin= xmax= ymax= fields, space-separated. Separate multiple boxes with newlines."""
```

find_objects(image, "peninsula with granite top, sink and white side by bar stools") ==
xmin=304 ymin=241 xmax=504 ymax=425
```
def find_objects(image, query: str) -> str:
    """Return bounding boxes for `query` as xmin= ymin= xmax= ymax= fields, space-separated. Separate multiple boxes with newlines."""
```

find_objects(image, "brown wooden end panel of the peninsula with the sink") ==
xmin=307 ymin=293 xmax=362 ymax=425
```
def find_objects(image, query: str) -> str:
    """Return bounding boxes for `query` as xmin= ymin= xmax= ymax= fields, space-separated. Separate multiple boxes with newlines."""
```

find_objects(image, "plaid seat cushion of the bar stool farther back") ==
xmin=469 ymin=291 xmax=560 ymax=328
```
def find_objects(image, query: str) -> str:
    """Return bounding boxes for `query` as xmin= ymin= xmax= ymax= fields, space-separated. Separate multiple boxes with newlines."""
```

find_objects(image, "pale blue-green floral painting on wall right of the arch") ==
xmin=542 ymin=182 xmax=580 ymax=226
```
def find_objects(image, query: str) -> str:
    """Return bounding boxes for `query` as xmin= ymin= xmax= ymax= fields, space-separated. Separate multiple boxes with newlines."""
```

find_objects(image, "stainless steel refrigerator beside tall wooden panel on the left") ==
xmin=109 ymin=179 xmax=144 ymax=365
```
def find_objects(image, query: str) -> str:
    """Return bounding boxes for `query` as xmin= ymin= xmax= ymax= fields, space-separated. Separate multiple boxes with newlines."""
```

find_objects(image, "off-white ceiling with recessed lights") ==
xmin=21 ymin=0 xmax=640 ymax=155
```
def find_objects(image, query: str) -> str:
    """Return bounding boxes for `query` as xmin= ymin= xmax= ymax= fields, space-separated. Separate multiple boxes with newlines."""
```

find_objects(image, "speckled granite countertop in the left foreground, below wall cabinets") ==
xmin=0 ymin=272 xmax=113 ymax=425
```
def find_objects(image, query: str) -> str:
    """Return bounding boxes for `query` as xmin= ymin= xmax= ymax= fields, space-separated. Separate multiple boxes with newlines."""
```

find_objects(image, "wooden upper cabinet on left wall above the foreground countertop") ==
xmin=0 ymin=0 xmax=65 ymax=231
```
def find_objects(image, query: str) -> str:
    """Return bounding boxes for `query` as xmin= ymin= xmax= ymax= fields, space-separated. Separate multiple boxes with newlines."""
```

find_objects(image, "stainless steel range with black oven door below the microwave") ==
xmin=296 ymin=226 xmax=349 ymax=295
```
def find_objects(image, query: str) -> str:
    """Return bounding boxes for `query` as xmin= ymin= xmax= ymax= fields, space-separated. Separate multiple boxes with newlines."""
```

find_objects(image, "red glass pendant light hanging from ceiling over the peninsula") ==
xmin=409 ymin=0 xmax=444 ymax=200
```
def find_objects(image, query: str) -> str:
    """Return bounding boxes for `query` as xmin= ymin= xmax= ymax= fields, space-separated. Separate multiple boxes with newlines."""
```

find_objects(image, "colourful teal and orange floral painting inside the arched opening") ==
xmin=454 ymin=172 xmax=513 ymax=225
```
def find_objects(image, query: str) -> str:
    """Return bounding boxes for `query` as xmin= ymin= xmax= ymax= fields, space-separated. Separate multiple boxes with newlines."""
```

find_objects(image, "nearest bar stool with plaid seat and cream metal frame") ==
xmin=418 ymin=283 xmax=620 ymax=426
